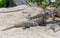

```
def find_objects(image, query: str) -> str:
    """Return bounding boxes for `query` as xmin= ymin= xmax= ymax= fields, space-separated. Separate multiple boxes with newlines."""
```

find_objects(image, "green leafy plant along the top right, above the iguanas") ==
xmin=28 ymin=0 xmax=60 ymax=8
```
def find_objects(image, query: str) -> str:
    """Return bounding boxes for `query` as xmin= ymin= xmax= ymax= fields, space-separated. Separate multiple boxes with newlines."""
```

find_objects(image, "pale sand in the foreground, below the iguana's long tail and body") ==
xmin=0 ymin=26 xmax=60 ymax=38
